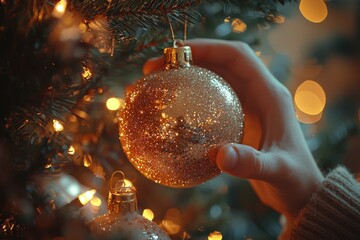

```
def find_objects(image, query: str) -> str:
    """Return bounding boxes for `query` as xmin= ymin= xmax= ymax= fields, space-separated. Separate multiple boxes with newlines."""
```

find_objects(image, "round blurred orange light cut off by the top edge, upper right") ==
xmin=299 ymin=0 xmax=328 ymax=23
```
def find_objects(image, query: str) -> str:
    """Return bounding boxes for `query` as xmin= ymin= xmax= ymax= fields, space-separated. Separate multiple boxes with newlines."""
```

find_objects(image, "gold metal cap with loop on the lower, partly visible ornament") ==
xmin=108 ymin=171 xmax=137 ymax=215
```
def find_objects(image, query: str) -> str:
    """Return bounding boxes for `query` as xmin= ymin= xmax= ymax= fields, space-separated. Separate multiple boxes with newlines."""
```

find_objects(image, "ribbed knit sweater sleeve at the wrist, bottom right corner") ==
xmin=280 ymin=167 xmax=360 ymax=240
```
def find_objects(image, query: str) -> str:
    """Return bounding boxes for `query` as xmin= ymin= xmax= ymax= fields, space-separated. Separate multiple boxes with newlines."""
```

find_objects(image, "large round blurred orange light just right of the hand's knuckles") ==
xmin=294 ymin=80 xmax=326 ymax=115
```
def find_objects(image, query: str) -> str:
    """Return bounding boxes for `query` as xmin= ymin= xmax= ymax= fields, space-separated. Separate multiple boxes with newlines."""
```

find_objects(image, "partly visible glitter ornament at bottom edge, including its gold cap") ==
xmin=89 ymin=171 xmax=170 ymax=240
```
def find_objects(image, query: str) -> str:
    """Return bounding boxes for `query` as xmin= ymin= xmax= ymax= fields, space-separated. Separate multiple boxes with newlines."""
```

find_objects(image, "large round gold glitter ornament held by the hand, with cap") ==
xmin=119 ymin=46 xmax=244 ymax=187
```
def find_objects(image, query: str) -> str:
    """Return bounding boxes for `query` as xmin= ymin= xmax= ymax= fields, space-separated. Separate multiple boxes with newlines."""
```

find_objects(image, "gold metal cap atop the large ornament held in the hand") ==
xmin=164 ymin=41 xmax=192 ymax=69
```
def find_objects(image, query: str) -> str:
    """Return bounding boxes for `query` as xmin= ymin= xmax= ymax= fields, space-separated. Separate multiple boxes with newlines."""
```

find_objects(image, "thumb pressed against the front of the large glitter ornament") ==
xmin=216 ymin=144 xmax=269 ymax=180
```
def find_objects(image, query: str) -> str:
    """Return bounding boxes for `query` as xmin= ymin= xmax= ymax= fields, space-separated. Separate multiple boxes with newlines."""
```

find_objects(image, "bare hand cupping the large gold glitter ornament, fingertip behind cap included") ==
xmin=144 ymin=39 xmax=324 ymax=221
